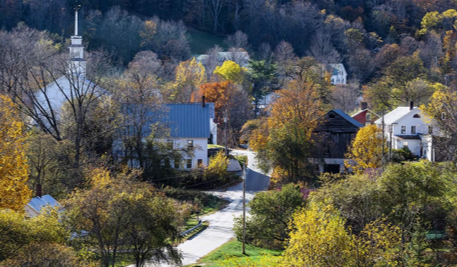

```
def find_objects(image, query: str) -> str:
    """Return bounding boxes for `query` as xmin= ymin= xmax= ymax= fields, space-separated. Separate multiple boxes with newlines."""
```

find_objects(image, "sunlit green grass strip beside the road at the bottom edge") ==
xmin=189 ymin=239 xmax=283 ymax=267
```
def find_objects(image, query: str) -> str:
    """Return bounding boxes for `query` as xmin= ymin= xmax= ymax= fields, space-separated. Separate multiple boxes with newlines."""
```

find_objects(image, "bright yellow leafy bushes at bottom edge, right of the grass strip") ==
xmin=280 ymin=202 xmax=404 ymax=267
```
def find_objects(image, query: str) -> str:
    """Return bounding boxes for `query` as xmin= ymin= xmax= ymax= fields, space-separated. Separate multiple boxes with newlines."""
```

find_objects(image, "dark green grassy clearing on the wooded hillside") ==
xmin=187 ymin=28 xmax=227 ymax=55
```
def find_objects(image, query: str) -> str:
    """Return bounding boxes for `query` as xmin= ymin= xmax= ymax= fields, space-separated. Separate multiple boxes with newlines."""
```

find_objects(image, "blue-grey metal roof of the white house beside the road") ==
xmin=165 ymin=103 xmax=214 ymax=138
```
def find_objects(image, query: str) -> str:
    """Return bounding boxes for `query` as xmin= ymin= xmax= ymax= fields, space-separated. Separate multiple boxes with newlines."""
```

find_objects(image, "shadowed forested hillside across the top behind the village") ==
xmin=0 ymin=0 xmax=457 ymax=91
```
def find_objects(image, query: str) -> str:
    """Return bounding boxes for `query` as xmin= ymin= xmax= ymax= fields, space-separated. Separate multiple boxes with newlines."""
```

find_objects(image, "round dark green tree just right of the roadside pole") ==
xmin=234 ymin=184 xmax=305 ymax=248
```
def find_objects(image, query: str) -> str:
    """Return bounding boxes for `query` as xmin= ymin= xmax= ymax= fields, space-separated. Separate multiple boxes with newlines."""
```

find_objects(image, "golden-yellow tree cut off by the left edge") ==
xmin=0 ymin=95 xmax=31 ymax=211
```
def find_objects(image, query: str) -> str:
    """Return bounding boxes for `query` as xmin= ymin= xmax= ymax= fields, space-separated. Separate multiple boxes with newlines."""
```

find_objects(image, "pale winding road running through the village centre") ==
xmin=138 ymin=150 xmax=270 ymax=267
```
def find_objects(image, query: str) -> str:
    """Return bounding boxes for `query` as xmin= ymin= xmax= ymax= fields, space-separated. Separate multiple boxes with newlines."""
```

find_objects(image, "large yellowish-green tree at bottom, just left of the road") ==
xmin=65 ymin=169 xmax=185 ymax=266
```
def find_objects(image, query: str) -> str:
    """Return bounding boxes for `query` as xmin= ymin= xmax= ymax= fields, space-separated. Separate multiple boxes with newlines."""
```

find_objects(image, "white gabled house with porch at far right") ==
xmin=375 ymin=103 xmax=439 ymax=161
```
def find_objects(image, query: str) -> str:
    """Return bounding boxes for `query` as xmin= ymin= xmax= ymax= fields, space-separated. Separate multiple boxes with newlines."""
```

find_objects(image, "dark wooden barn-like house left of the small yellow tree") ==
xmin=314 ymin=109 xmax=363 ymax=173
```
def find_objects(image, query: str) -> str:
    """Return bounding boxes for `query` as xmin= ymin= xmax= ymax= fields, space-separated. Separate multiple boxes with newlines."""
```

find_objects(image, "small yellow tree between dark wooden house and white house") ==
xmin=345 ymin=125 xmax=387 ymax=174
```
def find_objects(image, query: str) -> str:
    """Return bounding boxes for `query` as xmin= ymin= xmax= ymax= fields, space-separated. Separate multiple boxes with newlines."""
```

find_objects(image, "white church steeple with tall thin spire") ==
xmin=68 ymin=5 xmax=86 ymax=77
